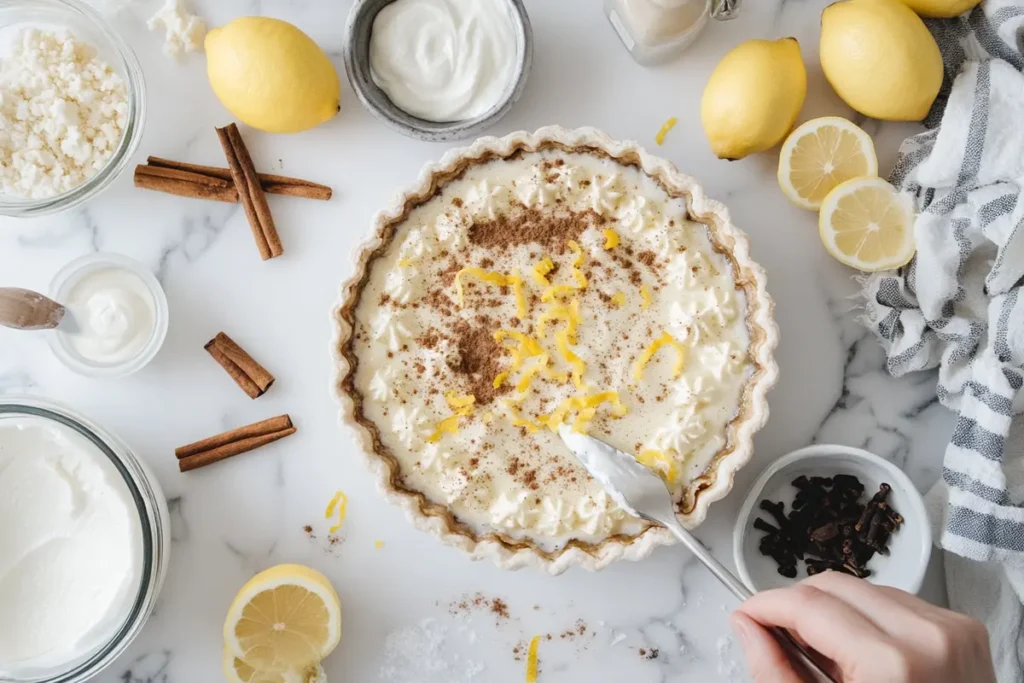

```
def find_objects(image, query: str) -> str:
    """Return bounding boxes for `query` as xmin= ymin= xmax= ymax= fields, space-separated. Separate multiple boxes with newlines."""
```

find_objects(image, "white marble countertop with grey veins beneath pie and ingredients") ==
xmin=0 ymin=0 xmax=953 ymax=683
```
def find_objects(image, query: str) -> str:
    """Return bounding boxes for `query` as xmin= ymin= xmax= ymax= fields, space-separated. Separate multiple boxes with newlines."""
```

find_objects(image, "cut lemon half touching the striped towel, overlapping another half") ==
xmin=818 ymin=178 xmax=915 ymax=271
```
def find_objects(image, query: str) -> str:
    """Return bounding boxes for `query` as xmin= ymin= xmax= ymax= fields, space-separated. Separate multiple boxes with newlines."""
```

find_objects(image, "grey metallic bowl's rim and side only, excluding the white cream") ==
xmin=345 ymin=0 xmax=534 ymax=142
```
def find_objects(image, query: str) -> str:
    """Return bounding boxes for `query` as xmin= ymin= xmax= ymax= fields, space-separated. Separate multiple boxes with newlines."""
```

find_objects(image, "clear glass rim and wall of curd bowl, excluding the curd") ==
xmin=0 ymin=0 xmax=145 ymax=217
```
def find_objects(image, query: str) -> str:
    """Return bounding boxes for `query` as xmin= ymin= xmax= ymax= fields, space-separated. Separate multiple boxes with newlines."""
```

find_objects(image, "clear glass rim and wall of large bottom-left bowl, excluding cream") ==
xmin=0 ymin=396 xmax=171 ymax=683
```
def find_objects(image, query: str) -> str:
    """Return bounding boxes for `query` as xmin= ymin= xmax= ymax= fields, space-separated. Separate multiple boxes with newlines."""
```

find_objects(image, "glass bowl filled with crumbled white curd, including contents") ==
xmin=0 ymin=0 xmax=145 ymax=217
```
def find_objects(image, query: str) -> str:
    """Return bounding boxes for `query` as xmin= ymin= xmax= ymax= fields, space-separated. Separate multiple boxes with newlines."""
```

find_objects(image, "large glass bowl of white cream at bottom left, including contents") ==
xmin=0 ymin=396 xmax=170 ymax=683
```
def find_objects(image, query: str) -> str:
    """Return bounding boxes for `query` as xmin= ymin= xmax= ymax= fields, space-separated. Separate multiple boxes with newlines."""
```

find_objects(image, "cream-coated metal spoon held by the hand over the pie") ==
xmin=558 ymin=425 xmax=839 ymax=683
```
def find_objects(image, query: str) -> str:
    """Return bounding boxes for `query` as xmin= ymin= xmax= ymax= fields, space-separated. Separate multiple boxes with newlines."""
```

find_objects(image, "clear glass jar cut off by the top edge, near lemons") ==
xmin=604 ymin=0 xmax=740 ymax=65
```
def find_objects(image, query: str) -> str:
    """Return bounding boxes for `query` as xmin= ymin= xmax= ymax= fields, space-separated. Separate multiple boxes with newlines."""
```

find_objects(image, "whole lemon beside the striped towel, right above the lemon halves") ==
xmin=820 ymin=0 xmax=942 ymax=121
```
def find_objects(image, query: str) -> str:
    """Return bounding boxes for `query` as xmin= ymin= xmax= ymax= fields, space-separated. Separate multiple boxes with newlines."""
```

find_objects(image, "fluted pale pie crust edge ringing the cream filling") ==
xmin=331 ymin=126 xmax=778 ymax=574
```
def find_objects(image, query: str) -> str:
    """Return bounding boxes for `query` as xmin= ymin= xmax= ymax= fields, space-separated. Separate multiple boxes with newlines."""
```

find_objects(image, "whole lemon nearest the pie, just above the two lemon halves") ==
xmin=700 ymin=38 xmax=807 ymax=159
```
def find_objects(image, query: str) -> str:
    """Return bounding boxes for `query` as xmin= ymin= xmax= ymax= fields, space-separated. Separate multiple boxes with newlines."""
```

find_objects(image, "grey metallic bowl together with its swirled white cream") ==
xmin=345 ymin=0 xmax=534 ymax=142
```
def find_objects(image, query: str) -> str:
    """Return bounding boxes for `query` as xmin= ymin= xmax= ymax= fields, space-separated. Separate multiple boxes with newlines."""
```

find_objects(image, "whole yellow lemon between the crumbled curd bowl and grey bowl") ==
xmin=205 ymin=16 xmax=341 ymax=133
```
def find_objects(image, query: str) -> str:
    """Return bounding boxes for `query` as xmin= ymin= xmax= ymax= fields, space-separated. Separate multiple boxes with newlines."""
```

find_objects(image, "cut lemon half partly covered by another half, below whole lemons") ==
xmin=778 ymin=116 xmax=879 ymax=209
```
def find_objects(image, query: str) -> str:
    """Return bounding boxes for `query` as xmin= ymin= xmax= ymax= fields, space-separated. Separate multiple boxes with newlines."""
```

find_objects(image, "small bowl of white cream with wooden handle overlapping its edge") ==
xmin=50 ymin=254 xmax=168 ymax=377
